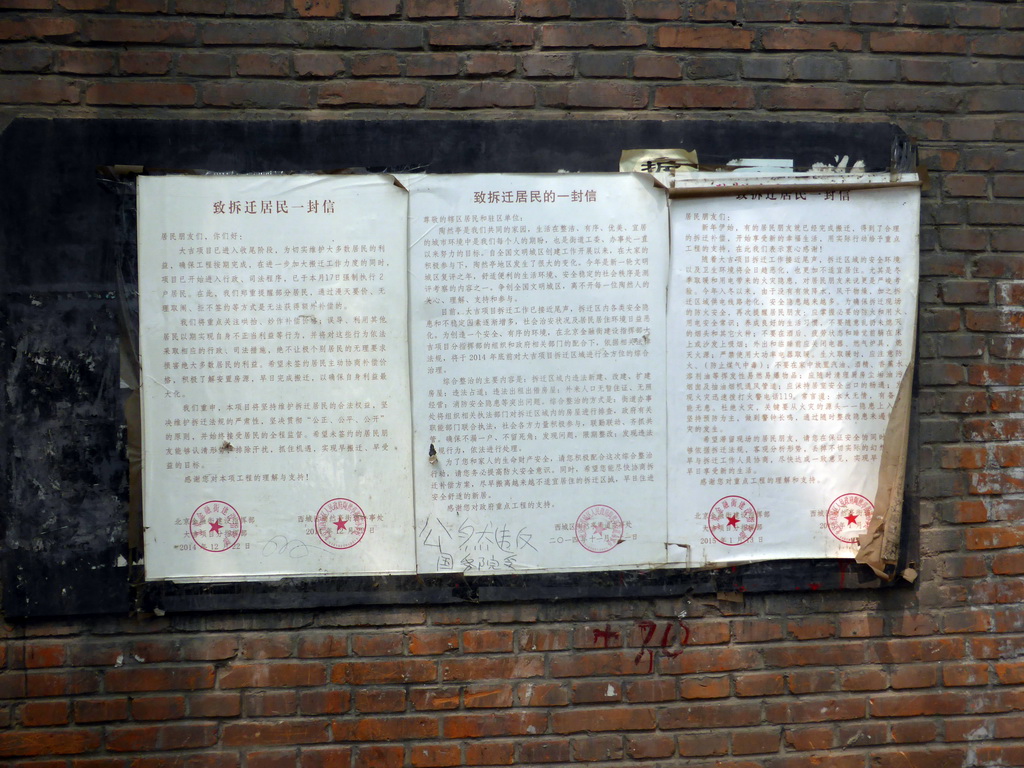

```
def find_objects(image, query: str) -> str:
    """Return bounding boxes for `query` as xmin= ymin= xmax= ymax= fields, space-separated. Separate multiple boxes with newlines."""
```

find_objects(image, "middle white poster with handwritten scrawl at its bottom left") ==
xmin=402 ymin=174 xmax=669 ymax=574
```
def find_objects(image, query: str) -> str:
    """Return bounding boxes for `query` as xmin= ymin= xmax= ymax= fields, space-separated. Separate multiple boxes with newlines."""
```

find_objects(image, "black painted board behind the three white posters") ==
xmin=0 ymin=119 xmax=916 ymax=618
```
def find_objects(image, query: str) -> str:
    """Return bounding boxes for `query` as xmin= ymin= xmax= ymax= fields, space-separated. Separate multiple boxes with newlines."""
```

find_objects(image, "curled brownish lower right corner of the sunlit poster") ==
xmin=854 ymin=364 xmax=916 ymax=582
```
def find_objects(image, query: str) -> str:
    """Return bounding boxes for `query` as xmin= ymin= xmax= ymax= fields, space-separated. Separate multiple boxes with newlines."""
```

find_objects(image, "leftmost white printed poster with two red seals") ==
xmin=138 ymin=176 xmax=416 ymax=581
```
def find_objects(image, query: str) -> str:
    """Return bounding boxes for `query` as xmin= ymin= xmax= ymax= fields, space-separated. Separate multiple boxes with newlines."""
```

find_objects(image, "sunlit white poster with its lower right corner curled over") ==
xmin=668 ymin=187 xmax=920 ymax=565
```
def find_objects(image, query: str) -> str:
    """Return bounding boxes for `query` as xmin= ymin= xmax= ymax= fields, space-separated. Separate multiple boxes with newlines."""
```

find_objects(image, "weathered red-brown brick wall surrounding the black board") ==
xmin=0 ymin=0 xmax=1024 ymax=768
